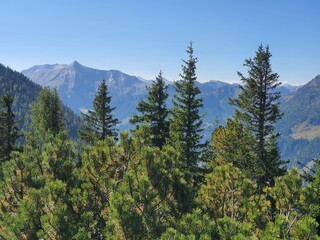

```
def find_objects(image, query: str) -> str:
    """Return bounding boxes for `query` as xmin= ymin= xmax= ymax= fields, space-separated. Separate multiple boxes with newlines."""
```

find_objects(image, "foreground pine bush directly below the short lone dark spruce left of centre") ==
xmin=72 ymin=139 xmax=122 ymax=239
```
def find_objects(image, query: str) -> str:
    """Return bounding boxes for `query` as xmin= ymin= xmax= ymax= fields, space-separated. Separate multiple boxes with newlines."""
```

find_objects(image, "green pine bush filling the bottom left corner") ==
xmin=0 ymin=131 xmax=78 ymax=239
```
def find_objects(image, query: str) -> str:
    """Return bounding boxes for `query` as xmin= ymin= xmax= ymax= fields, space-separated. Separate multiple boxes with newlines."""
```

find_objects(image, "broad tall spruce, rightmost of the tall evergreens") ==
xmin=230 ymin=45 xmax=285 ymax=186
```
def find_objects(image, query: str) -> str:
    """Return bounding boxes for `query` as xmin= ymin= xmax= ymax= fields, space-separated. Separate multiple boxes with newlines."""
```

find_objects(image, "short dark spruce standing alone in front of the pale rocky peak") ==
xmin=79 ymin=80 xmax=119 ymax=143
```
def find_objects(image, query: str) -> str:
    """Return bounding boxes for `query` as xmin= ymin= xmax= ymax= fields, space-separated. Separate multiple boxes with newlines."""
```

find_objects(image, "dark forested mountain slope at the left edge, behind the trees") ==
xmin=0 ymin=64 xmax=81 ymax=138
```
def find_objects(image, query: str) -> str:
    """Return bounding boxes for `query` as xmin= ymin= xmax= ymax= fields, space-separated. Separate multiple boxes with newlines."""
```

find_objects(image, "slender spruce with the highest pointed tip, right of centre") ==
xmin=170 ymin=43 xmax=203 ymax=173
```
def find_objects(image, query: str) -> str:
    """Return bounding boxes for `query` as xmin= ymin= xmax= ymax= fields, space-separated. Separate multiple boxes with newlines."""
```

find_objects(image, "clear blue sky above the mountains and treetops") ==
xmin=0 ymin=0 xmax=320 ymax=84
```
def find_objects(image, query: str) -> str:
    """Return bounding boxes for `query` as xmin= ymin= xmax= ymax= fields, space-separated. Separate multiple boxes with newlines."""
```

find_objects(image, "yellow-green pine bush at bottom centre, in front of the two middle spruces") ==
xmin=107 ymin=125 xmax=181 ymax=239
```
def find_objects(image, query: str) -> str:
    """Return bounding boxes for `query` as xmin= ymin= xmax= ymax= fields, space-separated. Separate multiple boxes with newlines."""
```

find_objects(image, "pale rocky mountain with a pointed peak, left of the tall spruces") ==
xmin=22 ymin=61 xmax=150 ymax=129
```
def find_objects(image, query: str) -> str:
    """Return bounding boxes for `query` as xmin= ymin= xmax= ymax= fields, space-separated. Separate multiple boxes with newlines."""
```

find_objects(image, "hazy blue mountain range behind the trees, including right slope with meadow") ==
xmin=22 ymin=61 xmax=320 ymax=165
